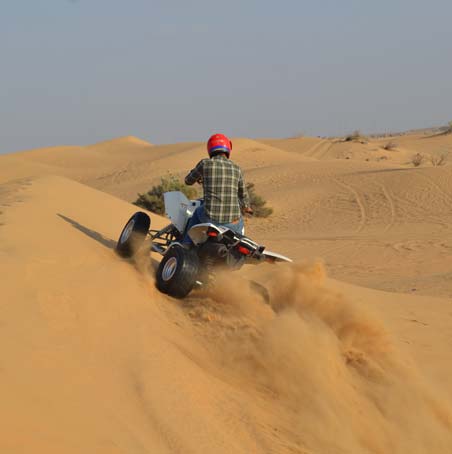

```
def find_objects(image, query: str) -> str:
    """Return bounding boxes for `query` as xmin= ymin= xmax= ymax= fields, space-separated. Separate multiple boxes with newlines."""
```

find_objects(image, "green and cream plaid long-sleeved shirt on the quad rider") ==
xmin=185 ymin=155 xmax=249 ymax=224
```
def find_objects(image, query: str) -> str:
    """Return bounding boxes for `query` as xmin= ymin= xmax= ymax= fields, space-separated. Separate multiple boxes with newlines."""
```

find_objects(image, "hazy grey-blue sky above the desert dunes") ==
xmin=0 ymin=0 xmax=452 ymax=153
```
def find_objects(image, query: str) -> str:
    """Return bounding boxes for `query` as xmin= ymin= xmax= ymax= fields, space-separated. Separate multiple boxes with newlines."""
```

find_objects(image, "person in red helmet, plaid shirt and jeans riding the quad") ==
xmin=183 ymin=134 xmax=253 ymax=243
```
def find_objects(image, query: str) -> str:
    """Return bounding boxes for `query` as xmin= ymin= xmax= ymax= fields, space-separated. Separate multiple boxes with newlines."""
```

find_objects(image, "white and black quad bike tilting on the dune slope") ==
xmin=116 ymin=191 xmax=292 ymax=298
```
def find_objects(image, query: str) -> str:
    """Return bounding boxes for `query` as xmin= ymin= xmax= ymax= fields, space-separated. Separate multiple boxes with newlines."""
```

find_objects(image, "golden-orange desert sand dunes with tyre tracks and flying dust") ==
xmin=0 ymin=133 xmax=452 ymax=454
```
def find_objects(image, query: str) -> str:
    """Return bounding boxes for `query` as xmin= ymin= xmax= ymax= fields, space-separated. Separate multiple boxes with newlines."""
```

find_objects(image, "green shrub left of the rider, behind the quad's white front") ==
xmin=133 ymin=174 xmax=198 ymax=214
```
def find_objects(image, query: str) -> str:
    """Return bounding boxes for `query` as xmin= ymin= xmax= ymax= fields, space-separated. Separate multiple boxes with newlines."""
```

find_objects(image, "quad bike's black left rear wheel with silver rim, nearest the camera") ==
xmin=156 ymin=244 xmax=199 ymax=298
